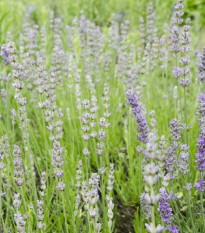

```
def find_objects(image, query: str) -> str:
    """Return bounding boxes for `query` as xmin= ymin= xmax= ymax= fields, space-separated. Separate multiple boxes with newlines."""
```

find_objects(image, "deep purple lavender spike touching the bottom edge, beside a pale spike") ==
xmin=158 ymin=188 xmax=179 ymax=233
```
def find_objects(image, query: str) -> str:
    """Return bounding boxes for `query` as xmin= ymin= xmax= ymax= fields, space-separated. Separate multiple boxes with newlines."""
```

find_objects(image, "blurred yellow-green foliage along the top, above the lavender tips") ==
xmin=0 ymin=0 xmax=205 ymax=42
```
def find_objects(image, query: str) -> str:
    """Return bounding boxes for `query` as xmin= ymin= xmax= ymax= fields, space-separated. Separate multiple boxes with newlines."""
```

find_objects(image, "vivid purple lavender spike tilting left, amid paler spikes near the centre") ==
xmin=127 ymin=90 xmax=149 ymax=143
